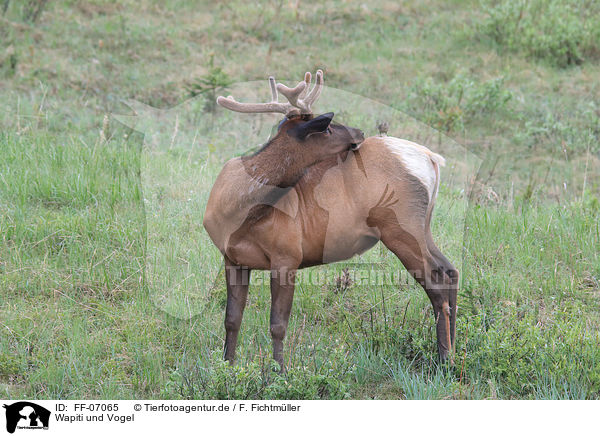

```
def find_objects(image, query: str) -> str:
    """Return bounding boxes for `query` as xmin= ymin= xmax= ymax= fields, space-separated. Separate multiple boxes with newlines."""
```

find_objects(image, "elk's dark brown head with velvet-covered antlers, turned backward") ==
xmin=217 ymin=70 xmax=365 ymax=163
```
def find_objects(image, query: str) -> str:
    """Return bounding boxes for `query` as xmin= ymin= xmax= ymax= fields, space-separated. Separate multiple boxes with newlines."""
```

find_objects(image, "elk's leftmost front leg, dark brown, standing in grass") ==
xmin=224 ymin=259 xmax=250 ymax=363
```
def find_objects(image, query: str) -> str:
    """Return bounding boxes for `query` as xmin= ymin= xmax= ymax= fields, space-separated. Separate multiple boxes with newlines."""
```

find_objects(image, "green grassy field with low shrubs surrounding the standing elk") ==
xmin=0 ymin=0 xmax=600 ymax=399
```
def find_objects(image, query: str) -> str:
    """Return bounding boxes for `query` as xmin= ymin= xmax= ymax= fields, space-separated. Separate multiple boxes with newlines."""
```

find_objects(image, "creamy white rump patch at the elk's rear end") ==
xmin=383 ymin=136 xmax=446 ymax=200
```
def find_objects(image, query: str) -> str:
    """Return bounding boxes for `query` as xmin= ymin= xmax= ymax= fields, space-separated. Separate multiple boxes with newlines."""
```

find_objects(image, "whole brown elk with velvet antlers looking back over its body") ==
xmin=203 ymin=70 xmax=458 ymax=369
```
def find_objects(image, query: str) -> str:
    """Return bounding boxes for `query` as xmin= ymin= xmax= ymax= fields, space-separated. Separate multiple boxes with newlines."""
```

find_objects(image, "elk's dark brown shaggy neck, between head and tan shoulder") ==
xmin=242 ymin=142 xmax=315 ymax=188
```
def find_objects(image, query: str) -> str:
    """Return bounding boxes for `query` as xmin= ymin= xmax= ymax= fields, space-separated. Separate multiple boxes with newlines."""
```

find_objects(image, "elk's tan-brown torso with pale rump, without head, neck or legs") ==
xmin=204 ymin=137 xmax=444 ymax=269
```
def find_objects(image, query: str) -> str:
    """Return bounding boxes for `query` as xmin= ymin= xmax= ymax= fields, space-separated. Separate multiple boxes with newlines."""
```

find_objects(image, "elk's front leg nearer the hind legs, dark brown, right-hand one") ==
xmin=271 ymin=268 xmax=296 ymax=371
